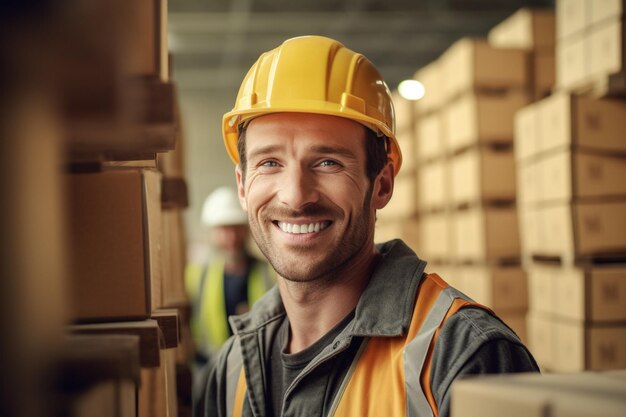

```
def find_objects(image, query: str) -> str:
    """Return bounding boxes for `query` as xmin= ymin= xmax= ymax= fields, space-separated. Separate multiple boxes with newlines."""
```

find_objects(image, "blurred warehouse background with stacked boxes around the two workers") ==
xmin=0 ymin=0 xmax=626 ymax=417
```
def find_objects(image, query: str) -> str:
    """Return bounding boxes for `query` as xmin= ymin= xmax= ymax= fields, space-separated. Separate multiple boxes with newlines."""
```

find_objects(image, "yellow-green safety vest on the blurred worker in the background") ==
xmin=200 ymin=261 xmax=267 ymax=348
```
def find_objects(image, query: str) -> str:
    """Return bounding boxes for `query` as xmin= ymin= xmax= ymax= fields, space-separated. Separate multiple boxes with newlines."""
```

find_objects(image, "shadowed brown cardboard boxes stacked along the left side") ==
xmin=56 ymin=0 xmax=191 ymax=417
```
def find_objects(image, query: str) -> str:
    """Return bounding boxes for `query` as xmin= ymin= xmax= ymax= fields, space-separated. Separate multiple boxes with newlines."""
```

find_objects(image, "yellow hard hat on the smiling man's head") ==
xmin=222 ymin=36 xmax=402 ymax=175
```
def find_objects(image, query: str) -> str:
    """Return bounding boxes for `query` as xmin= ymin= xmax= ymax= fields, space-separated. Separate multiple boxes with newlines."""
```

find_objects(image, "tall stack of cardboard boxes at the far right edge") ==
xmin=515 ymin=0 xmax=626 ymax=371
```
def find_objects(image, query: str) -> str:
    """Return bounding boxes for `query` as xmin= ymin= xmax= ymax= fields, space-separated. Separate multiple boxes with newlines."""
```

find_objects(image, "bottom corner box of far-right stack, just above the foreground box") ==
xmin=553 ymin=320 xmax=626 ymax=372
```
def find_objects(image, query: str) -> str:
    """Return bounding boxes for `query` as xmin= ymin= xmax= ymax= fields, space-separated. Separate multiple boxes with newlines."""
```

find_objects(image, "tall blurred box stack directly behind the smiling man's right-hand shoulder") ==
xmin=416 ymin=38 xmax=530 ymax=337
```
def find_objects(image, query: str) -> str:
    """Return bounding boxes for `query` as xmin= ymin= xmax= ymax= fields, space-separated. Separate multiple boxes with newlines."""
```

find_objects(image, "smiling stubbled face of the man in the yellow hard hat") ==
xmin=237 ymin=113 xmax=393 ymax=282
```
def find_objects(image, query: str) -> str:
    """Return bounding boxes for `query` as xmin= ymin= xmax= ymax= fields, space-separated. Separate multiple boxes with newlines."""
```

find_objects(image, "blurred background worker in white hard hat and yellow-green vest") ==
xmin=185 ymin=187 xmax=273 ymax=412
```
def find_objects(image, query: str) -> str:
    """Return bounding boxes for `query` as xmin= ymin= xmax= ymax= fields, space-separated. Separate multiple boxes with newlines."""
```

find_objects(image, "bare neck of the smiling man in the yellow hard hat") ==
xmin=278 ymin=252 xmax=380 ymax=353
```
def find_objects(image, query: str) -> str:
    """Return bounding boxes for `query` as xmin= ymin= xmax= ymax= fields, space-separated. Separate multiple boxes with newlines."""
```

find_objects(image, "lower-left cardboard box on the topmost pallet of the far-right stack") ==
xmin=555 ymin=34 xmax=591 ymax=91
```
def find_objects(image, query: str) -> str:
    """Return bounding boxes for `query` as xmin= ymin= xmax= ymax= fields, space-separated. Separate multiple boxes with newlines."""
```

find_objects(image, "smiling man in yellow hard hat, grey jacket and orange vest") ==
xmin=205 ymin=36 xmax=537 ymax=417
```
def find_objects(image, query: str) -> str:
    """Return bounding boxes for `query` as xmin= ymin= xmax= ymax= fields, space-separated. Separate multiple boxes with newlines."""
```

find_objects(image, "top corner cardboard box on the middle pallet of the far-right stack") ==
xmin=537 ymin=92 xmax=626 ymax=153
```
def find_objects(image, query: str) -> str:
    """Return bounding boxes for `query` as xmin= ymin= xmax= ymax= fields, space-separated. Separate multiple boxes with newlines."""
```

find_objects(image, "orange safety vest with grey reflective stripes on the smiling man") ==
xmin=227 ymin=274 xmax=489 ymax=417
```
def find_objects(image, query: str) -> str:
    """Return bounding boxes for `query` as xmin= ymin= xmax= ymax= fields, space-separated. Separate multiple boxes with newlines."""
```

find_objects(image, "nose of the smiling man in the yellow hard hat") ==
xmin=278 ymin=166 xmax=319 ymax=210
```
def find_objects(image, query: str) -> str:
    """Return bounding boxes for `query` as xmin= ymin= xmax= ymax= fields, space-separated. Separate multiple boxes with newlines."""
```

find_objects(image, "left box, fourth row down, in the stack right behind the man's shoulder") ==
xmin=418 ymin=212 xmax=453 ymax=261
